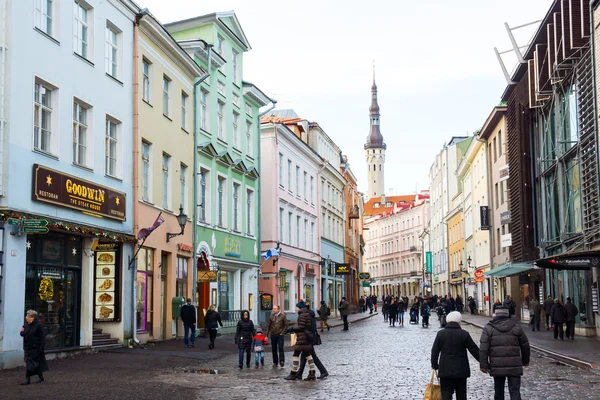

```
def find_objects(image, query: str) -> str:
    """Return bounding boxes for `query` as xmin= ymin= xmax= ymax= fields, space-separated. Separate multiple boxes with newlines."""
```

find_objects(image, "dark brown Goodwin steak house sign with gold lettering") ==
xmin=32 ymin=164 xmax=127 ymax=221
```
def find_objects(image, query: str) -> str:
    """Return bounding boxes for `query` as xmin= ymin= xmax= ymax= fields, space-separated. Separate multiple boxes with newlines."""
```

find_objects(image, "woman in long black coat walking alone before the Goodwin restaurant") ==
xmin=21 ymin=310 xmax=48 ymax=385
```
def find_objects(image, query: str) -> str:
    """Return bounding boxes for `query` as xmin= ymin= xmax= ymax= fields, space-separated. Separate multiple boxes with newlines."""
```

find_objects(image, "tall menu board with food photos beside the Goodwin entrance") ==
xmin=94 ymin=243 xmax=121 ymax=322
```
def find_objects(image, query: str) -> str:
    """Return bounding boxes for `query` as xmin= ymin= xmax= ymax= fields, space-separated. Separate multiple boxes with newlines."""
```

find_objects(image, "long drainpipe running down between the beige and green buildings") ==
xmin=192 ymin=43 xmax=213 ymax=312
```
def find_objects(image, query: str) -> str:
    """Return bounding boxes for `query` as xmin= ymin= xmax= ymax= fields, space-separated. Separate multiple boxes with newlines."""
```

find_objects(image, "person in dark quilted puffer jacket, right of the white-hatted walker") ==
xmin=479 ymin=307 xmax=530 ymax=400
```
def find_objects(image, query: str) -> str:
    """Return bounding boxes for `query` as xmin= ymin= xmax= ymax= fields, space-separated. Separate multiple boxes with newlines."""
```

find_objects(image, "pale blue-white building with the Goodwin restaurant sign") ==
xmin=0 ymin=0 xmax=138 ymax=368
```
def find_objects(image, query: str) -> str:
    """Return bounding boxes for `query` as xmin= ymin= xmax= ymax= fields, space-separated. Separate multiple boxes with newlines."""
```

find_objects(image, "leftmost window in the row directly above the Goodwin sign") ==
xmin=33 ymin=83 xmax=52 ymax=153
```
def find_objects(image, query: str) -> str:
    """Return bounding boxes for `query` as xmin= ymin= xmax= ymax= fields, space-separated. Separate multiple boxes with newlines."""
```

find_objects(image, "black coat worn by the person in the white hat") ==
xmin=431 ymin=322 xmax=479 ymax=378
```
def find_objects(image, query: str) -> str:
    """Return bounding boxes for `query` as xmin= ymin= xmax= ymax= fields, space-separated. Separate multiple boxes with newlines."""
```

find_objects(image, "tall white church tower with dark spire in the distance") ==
xmin=365 ymin=67 xmax=387 ymax=198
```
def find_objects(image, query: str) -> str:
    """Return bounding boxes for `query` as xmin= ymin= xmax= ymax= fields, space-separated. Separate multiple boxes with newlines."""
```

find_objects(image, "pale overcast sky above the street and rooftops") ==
xmin=137 ymin=0 xmax=552 ymax=195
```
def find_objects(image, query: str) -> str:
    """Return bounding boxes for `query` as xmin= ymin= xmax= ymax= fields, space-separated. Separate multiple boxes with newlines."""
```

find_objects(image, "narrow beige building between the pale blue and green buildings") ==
xmin=134 ymin=14 xmax=204 ymax=342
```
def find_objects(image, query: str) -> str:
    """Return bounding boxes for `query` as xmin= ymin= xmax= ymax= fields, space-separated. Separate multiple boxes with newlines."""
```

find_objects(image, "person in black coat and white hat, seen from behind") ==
xmin=431 ymin=311 xmax=479 ymax=400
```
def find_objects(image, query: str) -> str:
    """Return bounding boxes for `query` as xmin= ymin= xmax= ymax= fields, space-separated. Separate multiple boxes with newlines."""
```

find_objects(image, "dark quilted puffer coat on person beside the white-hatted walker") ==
xmin=479 ymin=317 xmax=530 ymax=376
